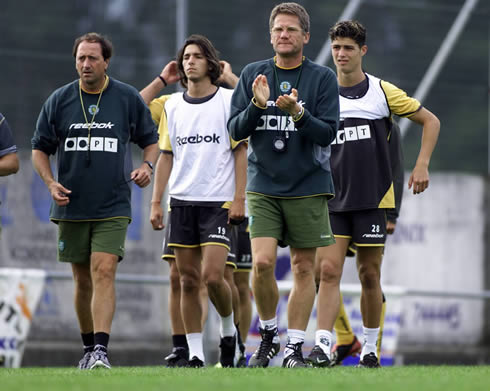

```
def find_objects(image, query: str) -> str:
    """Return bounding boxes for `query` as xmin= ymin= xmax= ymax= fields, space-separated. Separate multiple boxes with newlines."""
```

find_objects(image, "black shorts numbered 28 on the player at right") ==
xmin=330 ymin=209 xmax=386 ymax=247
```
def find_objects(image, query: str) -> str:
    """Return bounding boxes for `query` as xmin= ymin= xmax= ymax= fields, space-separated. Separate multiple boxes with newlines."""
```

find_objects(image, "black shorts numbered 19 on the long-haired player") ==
xmin=168 ymin=199 xmax=231 ymax=251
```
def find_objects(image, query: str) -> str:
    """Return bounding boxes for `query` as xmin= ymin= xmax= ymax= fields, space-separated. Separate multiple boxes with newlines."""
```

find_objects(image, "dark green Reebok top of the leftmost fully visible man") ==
xmin=31 ymin=78 xmax=158 ymax=222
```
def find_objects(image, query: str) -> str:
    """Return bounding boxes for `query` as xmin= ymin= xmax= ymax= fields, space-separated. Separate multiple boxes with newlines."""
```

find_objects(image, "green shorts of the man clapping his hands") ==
xmin=247 ymin=193 xmax=335 ymax=248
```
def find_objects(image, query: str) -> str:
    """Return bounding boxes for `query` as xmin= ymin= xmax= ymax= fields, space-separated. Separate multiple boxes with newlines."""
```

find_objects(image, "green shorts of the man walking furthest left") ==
xmin=58 ymin=218 xmax=129 ymax=263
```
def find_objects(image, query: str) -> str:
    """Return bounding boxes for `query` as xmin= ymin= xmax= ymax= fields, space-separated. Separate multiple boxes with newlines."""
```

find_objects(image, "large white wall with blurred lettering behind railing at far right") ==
xmin=381 ymin=174 xmax=488 ymax=345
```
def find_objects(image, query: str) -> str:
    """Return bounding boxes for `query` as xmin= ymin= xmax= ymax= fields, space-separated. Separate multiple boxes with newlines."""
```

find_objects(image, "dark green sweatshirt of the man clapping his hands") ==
xmin=228 ymin=59 xmax=339 ymax=198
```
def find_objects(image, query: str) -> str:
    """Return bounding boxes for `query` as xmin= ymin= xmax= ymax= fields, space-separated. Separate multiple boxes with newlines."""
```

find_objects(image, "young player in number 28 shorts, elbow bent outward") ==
xmin=308 ymin=21 xmax=440 ymax=368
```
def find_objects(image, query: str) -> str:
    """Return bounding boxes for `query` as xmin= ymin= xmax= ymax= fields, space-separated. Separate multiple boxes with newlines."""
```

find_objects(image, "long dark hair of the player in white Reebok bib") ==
xmin=177 ymin=34 xmax=221 ymax=88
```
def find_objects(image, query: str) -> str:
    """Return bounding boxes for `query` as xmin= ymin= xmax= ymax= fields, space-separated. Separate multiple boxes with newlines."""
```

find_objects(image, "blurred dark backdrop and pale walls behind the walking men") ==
xmin=0 ymin=0 xmax=490 ymax=365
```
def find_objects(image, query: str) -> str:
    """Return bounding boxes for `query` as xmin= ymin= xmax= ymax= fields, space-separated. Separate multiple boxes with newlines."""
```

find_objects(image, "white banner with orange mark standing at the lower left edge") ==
xmin=0 ymin=268 xmax=46 ymax=368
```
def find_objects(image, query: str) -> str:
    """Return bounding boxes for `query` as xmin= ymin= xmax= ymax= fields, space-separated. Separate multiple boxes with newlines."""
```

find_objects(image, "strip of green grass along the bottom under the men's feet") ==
xmin=0 ymin=366 xmax=490 ymax=391
